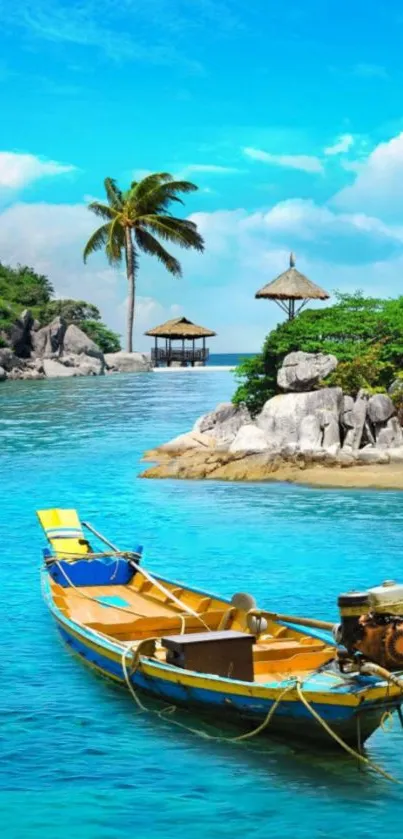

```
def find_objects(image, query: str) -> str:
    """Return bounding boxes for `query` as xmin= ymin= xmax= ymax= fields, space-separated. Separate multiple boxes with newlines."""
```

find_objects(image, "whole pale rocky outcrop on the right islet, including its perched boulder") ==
xmin=146 ymin=353 xmax=403 ymax=485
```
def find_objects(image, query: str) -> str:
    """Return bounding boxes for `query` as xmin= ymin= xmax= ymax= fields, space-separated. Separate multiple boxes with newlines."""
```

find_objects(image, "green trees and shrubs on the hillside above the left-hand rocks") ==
xmin=0 ymin=263 xmax=120 ymax=352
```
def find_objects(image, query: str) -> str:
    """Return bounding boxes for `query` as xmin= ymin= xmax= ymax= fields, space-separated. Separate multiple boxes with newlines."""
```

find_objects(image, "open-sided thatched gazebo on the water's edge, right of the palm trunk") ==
xmin=145 ymin=318 xmax=216 ymax=367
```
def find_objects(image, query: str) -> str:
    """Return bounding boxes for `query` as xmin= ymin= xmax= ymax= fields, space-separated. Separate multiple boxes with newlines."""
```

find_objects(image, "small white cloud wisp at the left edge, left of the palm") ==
xmin=0 ymin=151 xmax=75 ymax=189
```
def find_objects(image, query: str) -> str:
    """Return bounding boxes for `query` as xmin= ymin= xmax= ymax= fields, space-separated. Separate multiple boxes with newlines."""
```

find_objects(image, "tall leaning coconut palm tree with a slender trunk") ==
xmin=83 ymin=172 xmax=204 ymax=352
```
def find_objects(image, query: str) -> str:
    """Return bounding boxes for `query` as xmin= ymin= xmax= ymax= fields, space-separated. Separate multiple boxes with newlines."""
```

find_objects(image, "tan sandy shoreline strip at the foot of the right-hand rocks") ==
xmin=139 ymin=449 xmax=403 ymax=491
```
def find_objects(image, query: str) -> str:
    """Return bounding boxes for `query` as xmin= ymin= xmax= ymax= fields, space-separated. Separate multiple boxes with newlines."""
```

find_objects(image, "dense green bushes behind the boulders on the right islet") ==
xmin=234 ymin=292 xmax=403 ymax=414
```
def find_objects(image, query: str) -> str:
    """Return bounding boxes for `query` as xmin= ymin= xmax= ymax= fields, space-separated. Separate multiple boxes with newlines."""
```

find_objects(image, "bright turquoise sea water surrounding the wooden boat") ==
xmin=0 ymin=372 xmax=403 ymax=839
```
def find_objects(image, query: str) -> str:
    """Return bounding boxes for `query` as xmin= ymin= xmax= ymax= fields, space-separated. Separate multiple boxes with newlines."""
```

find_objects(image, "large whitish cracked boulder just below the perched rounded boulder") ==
xmin=256 ymin=387 xmax=343 ymax=452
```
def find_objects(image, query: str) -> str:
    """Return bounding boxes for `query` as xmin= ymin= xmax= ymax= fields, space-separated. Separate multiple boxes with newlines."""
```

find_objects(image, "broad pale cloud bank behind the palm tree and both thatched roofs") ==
xmin=5 ymin=130 xmax=403 ymax=352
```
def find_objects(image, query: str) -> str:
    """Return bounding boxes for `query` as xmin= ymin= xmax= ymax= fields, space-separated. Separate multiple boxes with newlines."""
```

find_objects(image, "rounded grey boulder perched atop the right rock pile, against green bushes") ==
xmin=277 ymin=352 xmax=338 ymax=393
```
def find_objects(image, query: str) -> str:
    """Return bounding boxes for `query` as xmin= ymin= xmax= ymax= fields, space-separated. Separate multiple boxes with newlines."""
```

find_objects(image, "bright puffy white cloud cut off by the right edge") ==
xmin=332 ymin=132 xmax=403 ymax=222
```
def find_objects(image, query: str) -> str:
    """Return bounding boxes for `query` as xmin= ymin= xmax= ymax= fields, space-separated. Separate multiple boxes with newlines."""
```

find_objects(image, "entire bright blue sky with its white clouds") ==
xmin=0 ymin=0 xmax=403 ymax=351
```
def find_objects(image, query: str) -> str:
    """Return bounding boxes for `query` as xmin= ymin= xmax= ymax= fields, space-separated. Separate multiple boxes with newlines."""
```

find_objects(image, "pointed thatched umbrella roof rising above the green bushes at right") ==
xmin=255 ymin=253 xmax=330 ymax=320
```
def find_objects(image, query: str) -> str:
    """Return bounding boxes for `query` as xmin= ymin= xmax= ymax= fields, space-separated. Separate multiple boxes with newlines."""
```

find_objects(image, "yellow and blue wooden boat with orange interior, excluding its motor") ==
xmin=38 ymin=509 xmax=402 ymax=746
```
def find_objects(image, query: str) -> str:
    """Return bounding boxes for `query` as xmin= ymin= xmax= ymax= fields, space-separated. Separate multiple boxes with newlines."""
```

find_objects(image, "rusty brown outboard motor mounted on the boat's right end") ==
xmin=334 ymin=580 xmax=403 ymax=670
